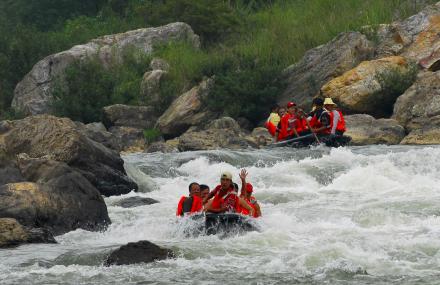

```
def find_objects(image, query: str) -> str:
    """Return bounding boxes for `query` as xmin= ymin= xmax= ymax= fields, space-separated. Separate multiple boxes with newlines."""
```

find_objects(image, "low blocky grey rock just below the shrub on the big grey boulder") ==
xmin=102 ymin=104 xmax=157 ymax=129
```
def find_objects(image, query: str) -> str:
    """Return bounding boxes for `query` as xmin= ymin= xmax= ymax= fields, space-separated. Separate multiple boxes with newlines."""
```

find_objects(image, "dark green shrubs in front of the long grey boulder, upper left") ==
xmin=52 ymin=52 xmax=150 ymax=123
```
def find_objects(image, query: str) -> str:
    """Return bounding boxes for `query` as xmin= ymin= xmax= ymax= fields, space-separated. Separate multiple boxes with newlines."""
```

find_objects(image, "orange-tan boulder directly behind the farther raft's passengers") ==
xmin=321 ymin=56 xmax=411 ymax=116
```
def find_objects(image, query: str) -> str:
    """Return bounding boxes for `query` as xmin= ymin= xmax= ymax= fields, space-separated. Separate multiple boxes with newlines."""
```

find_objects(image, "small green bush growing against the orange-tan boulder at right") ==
xmin=376 ymin=62 xmax=419 ymax=115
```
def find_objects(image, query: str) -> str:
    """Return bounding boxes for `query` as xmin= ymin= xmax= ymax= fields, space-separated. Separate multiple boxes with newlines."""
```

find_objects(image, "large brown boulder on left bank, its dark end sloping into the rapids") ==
xmin=0 ymin=115 xmax=137 ymax=196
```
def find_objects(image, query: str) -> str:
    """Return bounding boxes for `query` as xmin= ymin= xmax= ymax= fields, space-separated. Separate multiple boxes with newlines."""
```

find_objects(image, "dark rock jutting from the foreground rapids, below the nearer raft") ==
xmin=104 ymin=240 xmax=174 ymax=266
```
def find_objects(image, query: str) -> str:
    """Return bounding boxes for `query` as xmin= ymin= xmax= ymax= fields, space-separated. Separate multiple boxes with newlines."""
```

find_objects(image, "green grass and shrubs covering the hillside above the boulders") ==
xmin=0 ymin=0 xmax=436 ymax=124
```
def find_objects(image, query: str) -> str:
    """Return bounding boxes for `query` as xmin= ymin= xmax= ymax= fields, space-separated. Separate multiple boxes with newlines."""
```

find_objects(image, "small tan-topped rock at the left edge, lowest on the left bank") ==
xmin=0 ymin=218 xmax=56 ymax=248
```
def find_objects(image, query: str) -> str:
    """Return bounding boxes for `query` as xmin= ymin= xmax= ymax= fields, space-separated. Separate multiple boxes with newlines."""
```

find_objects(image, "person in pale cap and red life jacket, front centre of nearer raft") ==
xmin=205 ymin=172 xmax=254 ymax=214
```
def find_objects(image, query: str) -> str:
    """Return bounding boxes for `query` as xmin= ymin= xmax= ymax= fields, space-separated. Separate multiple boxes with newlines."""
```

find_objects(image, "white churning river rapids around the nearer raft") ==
xmin=0 ymin=146 xmax=440 ymax=284
